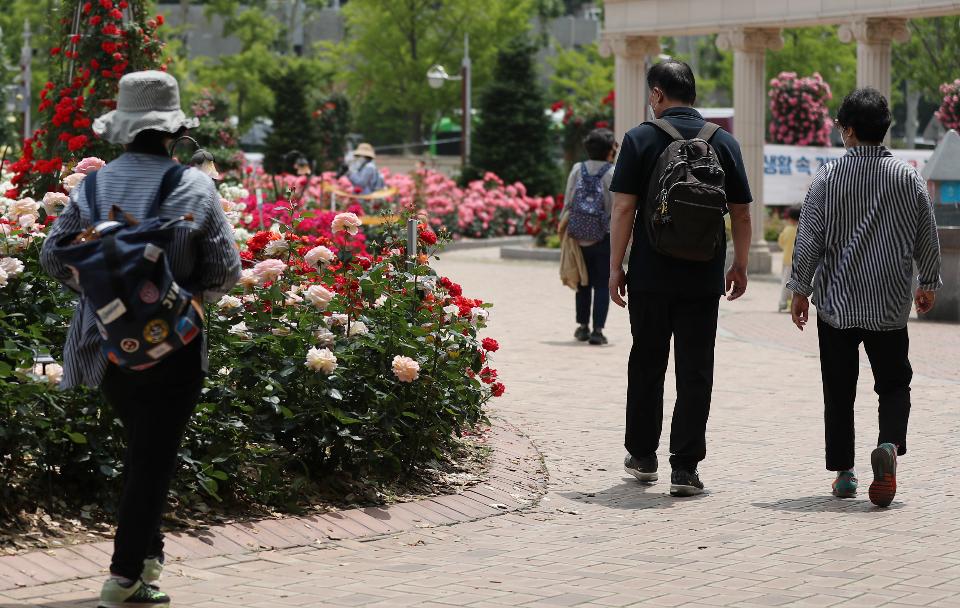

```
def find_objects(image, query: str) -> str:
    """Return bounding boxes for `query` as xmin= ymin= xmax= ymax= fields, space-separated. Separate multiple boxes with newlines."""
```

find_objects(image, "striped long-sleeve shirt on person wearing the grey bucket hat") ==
xmin=40 ymin=153 xmax=240 ymax=389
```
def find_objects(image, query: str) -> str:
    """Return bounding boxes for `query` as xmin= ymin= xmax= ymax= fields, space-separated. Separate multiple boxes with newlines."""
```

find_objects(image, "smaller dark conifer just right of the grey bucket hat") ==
xmin=263 ymin=60 xmax=322 ymax=173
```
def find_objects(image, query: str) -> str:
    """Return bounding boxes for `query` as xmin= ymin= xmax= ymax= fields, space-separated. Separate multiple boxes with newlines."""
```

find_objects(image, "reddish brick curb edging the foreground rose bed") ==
xmin=0 ymin=419 xmax=547 ymax=591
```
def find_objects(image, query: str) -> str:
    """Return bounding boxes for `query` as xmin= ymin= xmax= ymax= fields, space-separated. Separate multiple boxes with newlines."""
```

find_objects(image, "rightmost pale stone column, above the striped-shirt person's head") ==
xmin=838 ymin=18 xmax=910 ymax=145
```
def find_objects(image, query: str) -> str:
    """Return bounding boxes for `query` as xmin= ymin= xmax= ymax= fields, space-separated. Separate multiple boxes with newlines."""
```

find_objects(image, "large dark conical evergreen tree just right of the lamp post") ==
xmin=464 ymin=39 xmax=559 ymax=194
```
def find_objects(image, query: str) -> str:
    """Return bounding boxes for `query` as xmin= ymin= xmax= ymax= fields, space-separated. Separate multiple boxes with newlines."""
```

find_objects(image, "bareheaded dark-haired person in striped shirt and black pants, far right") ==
xmin=787 ymin=88 xmax=942 ymax=507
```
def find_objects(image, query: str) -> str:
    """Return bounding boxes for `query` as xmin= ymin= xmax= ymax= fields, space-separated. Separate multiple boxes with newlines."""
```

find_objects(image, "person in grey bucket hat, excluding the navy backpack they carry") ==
xmin=41 ymin=71 xmax=240 ymax=608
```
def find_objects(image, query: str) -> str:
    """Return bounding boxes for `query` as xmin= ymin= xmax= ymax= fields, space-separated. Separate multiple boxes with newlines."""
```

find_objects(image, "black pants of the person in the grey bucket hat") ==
xmin=100 ymin=339 xmax=203 ymax=580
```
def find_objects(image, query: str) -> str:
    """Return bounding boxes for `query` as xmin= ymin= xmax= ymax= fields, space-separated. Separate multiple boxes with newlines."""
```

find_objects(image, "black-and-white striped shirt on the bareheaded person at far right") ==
xmin=787 ymin=146 xmax=942 ymax=331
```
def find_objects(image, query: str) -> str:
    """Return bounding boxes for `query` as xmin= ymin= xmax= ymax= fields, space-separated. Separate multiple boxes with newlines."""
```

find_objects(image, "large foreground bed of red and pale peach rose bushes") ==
xmin=0 ymin=162 xmax=504 ymax=514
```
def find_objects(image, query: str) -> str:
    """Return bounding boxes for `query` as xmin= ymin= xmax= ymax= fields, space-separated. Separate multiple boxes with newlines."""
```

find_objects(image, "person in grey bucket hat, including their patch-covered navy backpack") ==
xmin=42 ymin=71 xmax=240 ymax=608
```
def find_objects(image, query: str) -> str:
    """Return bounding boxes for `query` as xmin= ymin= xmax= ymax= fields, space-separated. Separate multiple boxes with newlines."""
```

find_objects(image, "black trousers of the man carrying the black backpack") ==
xmin=624 ymin=291 xmax=720 ymax=470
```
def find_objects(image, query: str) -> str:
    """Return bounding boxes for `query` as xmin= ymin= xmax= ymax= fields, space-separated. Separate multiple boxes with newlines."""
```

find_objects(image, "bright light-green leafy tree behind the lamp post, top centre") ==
xmin=336 ymin=0 xmax=536 ymax=147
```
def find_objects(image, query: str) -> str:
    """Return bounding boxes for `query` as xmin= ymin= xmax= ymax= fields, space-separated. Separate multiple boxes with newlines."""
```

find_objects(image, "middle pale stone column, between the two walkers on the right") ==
xmin=717 ymin=28 xmax=783 ymax=274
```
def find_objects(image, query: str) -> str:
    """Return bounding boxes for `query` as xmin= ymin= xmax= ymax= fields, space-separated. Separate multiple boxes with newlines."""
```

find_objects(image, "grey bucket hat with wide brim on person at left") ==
xmin=93 ymin=70 xmax=200 ymax=144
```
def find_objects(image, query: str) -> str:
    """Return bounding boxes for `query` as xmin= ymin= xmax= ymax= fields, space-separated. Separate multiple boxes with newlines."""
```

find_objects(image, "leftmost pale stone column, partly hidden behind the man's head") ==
xmin=600 ymin=34 xmax=660 ymax=142
